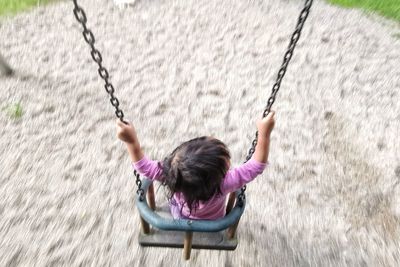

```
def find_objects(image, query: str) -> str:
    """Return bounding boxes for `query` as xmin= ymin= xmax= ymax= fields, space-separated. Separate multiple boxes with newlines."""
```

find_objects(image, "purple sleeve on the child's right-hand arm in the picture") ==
xmin=221 ymin=159 xmax=267 ymax=194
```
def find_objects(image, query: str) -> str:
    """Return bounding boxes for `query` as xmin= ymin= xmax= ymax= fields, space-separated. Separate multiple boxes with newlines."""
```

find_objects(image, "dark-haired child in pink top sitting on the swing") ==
xmin=117 ymin=111 xmax=275 ymax=220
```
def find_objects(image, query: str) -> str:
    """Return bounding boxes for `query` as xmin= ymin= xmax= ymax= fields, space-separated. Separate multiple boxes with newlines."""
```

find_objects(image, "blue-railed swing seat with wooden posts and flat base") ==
xmin=136 ymin=179 xmax=246 ymax=258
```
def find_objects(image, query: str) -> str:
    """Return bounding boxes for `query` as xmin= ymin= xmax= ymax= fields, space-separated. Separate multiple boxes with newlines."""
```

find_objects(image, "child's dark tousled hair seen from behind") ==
xmin=163 ymin=136 xmax=230 ymax=213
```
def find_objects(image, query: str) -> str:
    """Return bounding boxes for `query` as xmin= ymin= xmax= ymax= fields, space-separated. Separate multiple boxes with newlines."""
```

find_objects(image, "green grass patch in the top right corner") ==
xmin=328 ymin=0 xmax=400 ymax=22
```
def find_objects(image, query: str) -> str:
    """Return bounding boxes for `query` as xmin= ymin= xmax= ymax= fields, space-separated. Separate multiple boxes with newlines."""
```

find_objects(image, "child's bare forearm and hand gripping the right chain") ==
xmin=253 ymin=111 xmax=275 ymax=163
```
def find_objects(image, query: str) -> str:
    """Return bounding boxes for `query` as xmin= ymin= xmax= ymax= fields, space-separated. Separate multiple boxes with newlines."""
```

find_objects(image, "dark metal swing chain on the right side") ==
xmin=238 ymin=0 xmax=313 ymax=205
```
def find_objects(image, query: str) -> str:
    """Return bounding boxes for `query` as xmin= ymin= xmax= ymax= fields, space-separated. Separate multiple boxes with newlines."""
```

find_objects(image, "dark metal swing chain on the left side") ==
xmin=72 ymin=0 xmax=144 ymax=201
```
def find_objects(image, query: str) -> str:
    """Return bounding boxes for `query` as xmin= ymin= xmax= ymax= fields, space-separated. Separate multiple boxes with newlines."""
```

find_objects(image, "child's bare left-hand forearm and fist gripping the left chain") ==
xmin=117 ymin=120 xmax=144 ymax=162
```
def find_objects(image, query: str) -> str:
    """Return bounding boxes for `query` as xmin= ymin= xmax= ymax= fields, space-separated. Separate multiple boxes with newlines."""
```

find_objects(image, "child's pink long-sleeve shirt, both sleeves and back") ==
xmin=133 ymin=156 xmax=267 ymax=220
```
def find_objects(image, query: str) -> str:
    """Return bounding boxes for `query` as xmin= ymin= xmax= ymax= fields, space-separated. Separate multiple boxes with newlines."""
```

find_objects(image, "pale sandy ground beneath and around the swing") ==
xmin=0 ymin=0 xmax=400 ymax=267
